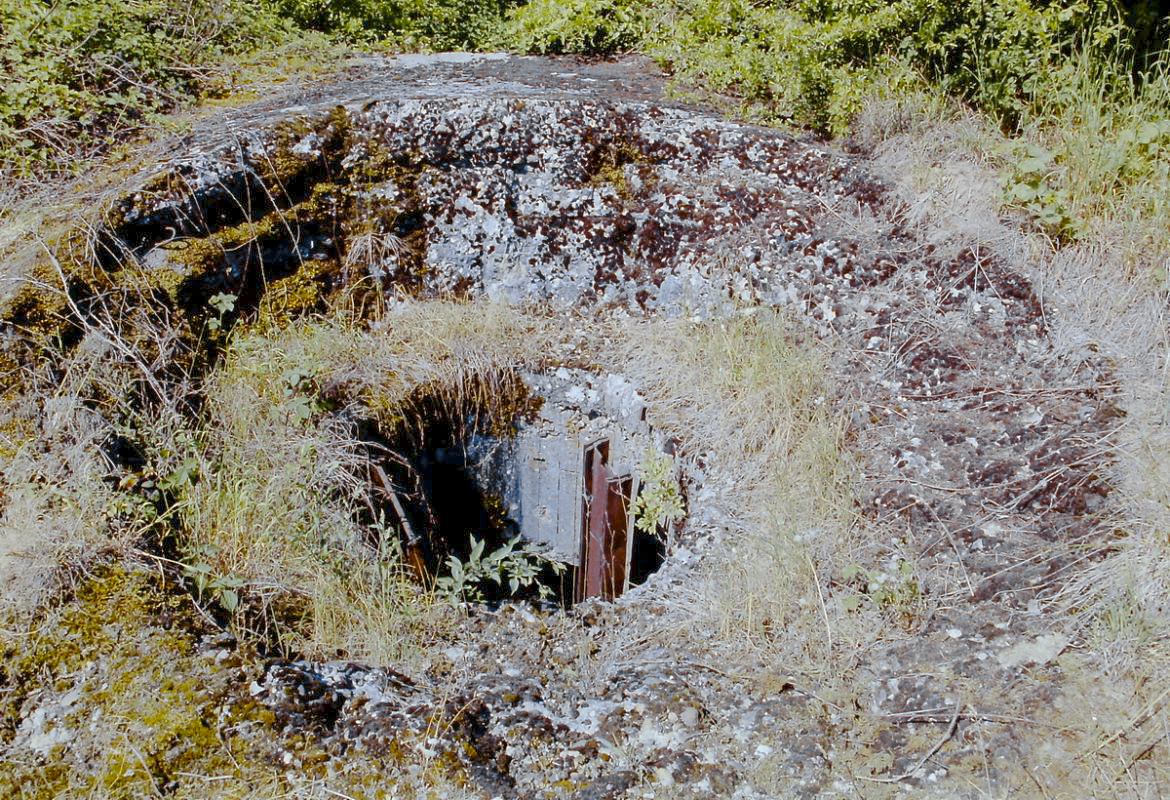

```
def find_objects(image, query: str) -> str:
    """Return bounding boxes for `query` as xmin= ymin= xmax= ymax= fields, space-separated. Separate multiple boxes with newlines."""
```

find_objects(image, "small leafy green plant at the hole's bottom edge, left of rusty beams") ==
xmin=435 ymin=536 xmax=565 ymax=604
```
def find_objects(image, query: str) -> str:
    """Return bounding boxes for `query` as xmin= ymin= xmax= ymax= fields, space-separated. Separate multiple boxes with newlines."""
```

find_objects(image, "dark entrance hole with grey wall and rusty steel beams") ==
xmin=376 ymin=373 xmax=666 ymax=608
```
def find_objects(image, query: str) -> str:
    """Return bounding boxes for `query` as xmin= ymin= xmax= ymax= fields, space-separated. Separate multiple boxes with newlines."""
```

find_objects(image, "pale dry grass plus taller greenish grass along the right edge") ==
xmin=847 ymin=83 xmax=1170 ymax=798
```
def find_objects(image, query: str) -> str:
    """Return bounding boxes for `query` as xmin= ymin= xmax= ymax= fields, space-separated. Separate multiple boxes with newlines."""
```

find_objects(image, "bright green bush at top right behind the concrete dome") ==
xmin=651 ymin=0 xmax=1135 ymax=133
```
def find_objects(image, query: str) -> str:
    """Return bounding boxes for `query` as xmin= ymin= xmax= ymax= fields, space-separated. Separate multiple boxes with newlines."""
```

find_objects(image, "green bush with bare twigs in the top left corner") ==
xmin=0 ymin=0 xmax=281 ymax=170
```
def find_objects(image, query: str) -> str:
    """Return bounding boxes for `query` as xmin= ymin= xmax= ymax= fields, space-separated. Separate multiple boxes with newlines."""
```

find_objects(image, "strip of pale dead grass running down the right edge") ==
xmin=862 ymin=92 xmax=1170 ymax=798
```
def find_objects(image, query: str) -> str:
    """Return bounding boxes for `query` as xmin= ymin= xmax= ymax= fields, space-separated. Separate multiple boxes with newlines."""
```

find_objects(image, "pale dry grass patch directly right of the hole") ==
xmin=610 ymin=311 xmax=852 ymax=671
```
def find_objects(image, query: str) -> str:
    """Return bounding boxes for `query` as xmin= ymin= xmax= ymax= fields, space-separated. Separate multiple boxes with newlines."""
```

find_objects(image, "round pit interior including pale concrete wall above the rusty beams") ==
xmin=376 ymin=368 xmax=677 ymax=607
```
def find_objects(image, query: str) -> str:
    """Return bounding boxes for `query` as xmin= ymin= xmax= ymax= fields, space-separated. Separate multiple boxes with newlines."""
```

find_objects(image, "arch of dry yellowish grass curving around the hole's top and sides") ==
xmin=114 ymin=287 xmax=851 ymax=664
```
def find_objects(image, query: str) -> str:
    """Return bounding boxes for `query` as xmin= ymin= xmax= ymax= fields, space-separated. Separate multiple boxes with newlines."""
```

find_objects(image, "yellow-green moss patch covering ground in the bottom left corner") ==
xmin=0 ymin=567 xmax=297 ymax=798
